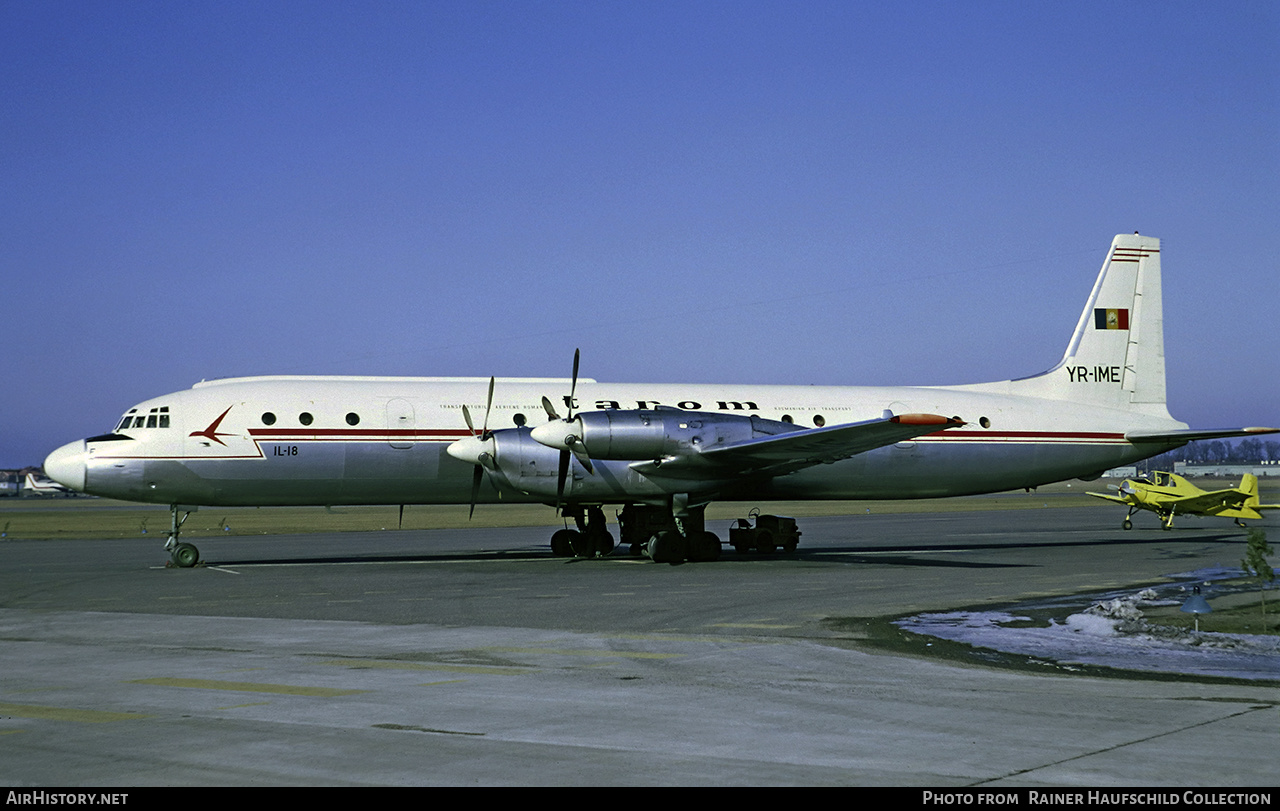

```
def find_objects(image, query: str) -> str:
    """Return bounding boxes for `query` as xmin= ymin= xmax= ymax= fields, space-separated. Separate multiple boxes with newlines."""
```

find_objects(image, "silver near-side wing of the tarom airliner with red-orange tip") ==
xmin=632 ymin=414 xmax=964 ymax=476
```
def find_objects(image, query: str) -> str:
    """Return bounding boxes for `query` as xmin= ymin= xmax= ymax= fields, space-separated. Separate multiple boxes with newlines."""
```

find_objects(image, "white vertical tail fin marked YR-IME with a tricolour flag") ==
xmin=1011 ymin=234 xmax=1170 ymax=418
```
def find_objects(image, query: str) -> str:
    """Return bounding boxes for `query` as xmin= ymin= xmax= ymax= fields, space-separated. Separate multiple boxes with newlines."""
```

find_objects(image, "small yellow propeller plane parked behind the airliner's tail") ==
xmin=1089 ymin=471 xmax=1280 ymax=530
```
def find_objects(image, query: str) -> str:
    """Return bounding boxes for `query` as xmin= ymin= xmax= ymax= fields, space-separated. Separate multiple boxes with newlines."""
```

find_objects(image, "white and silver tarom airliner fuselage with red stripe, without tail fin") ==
xmin=50 ymin=368 xmax=1183 ymax=505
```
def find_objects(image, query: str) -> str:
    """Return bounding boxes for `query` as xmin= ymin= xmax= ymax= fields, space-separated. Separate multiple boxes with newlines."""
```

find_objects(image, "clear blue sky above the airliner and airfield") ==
xmin=0 ymin=0 xmax=1280 ymax=467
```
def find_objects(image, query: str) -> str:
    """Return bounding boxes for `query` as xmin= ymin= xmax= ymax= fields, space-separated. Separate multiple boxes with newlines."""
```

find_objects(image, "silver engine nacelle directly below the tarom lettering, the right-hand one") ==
xmin=531 ymin=407 xmax=801 ymax=462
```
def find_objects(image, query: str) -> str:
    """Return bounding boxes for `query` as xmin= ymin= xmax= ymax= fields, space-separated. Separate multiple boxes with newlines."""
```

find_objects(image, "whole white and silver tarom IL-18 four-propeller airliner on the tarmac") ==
xmin=45 ymin=234 xmax=1276 ymax=567
